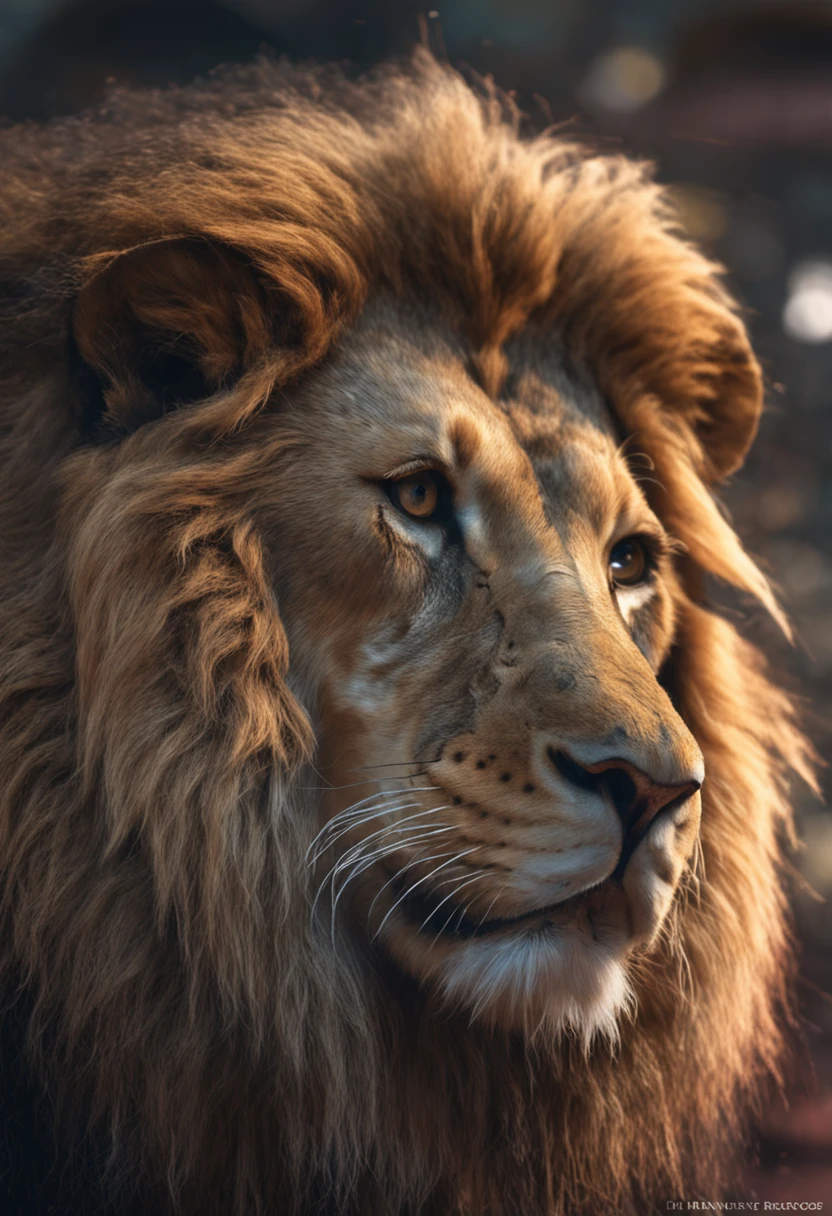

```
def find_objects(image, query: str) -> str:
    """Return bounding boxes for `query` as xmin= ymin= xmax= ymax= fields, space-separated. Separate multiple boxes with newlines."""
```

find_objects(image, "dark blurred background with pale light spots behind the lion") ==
xmin=0 ymin=0 xmax=832 ymax=1205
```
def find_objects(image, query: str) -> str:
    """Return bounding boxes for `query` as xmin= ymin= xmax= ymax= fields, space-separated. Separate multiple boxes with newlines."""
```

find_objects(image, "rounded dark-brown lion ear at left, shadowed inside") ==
xmin=72 ymin=237 xmax=274 ymax=434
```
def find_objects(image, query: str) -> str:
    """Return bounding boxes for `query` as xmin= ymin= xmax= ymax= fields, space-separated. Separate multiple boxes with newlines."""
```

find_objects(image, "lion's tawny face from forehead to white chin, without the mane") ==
xmin=265 ymin=305 xmax=703 ymax=1032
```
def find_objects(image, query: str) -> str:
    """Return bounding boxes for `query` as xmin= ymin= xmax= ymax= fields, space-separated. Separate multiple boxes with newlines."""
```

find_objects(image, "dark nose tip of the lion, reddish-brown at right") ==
xmin=549 ymin=748 xmax=702 ymax=857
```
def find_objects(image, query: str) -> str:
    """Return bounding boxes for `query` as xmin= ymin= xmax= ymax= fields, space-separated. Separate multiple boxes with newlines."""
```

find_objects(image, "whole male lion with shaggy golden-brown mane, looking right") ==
xmin=0 ymin=52 xmax=811 ymax=1216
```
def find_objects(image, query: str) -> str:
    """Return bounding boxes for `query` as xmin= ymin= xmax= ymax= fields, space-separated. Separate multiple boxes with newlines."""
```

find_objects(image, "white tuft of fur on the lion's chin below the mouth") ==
xmin=435 ymin=925 xmax=635 ymax=1048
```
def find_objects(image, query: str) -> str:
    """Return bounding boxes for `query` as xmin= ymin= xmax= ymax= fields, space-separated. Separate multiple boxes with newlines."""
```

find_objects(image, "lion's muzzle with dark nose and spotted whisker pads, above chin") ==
xmin=429 ymin=727 xmax=704 ymax=944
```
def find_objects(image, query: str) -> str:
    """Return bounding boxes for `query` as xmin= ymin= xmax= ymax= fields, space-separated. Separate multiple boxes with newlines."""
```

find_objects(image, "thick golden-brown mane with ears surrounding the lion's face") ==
xmin=0 ymin=54 xmax=809 ymax=1216
